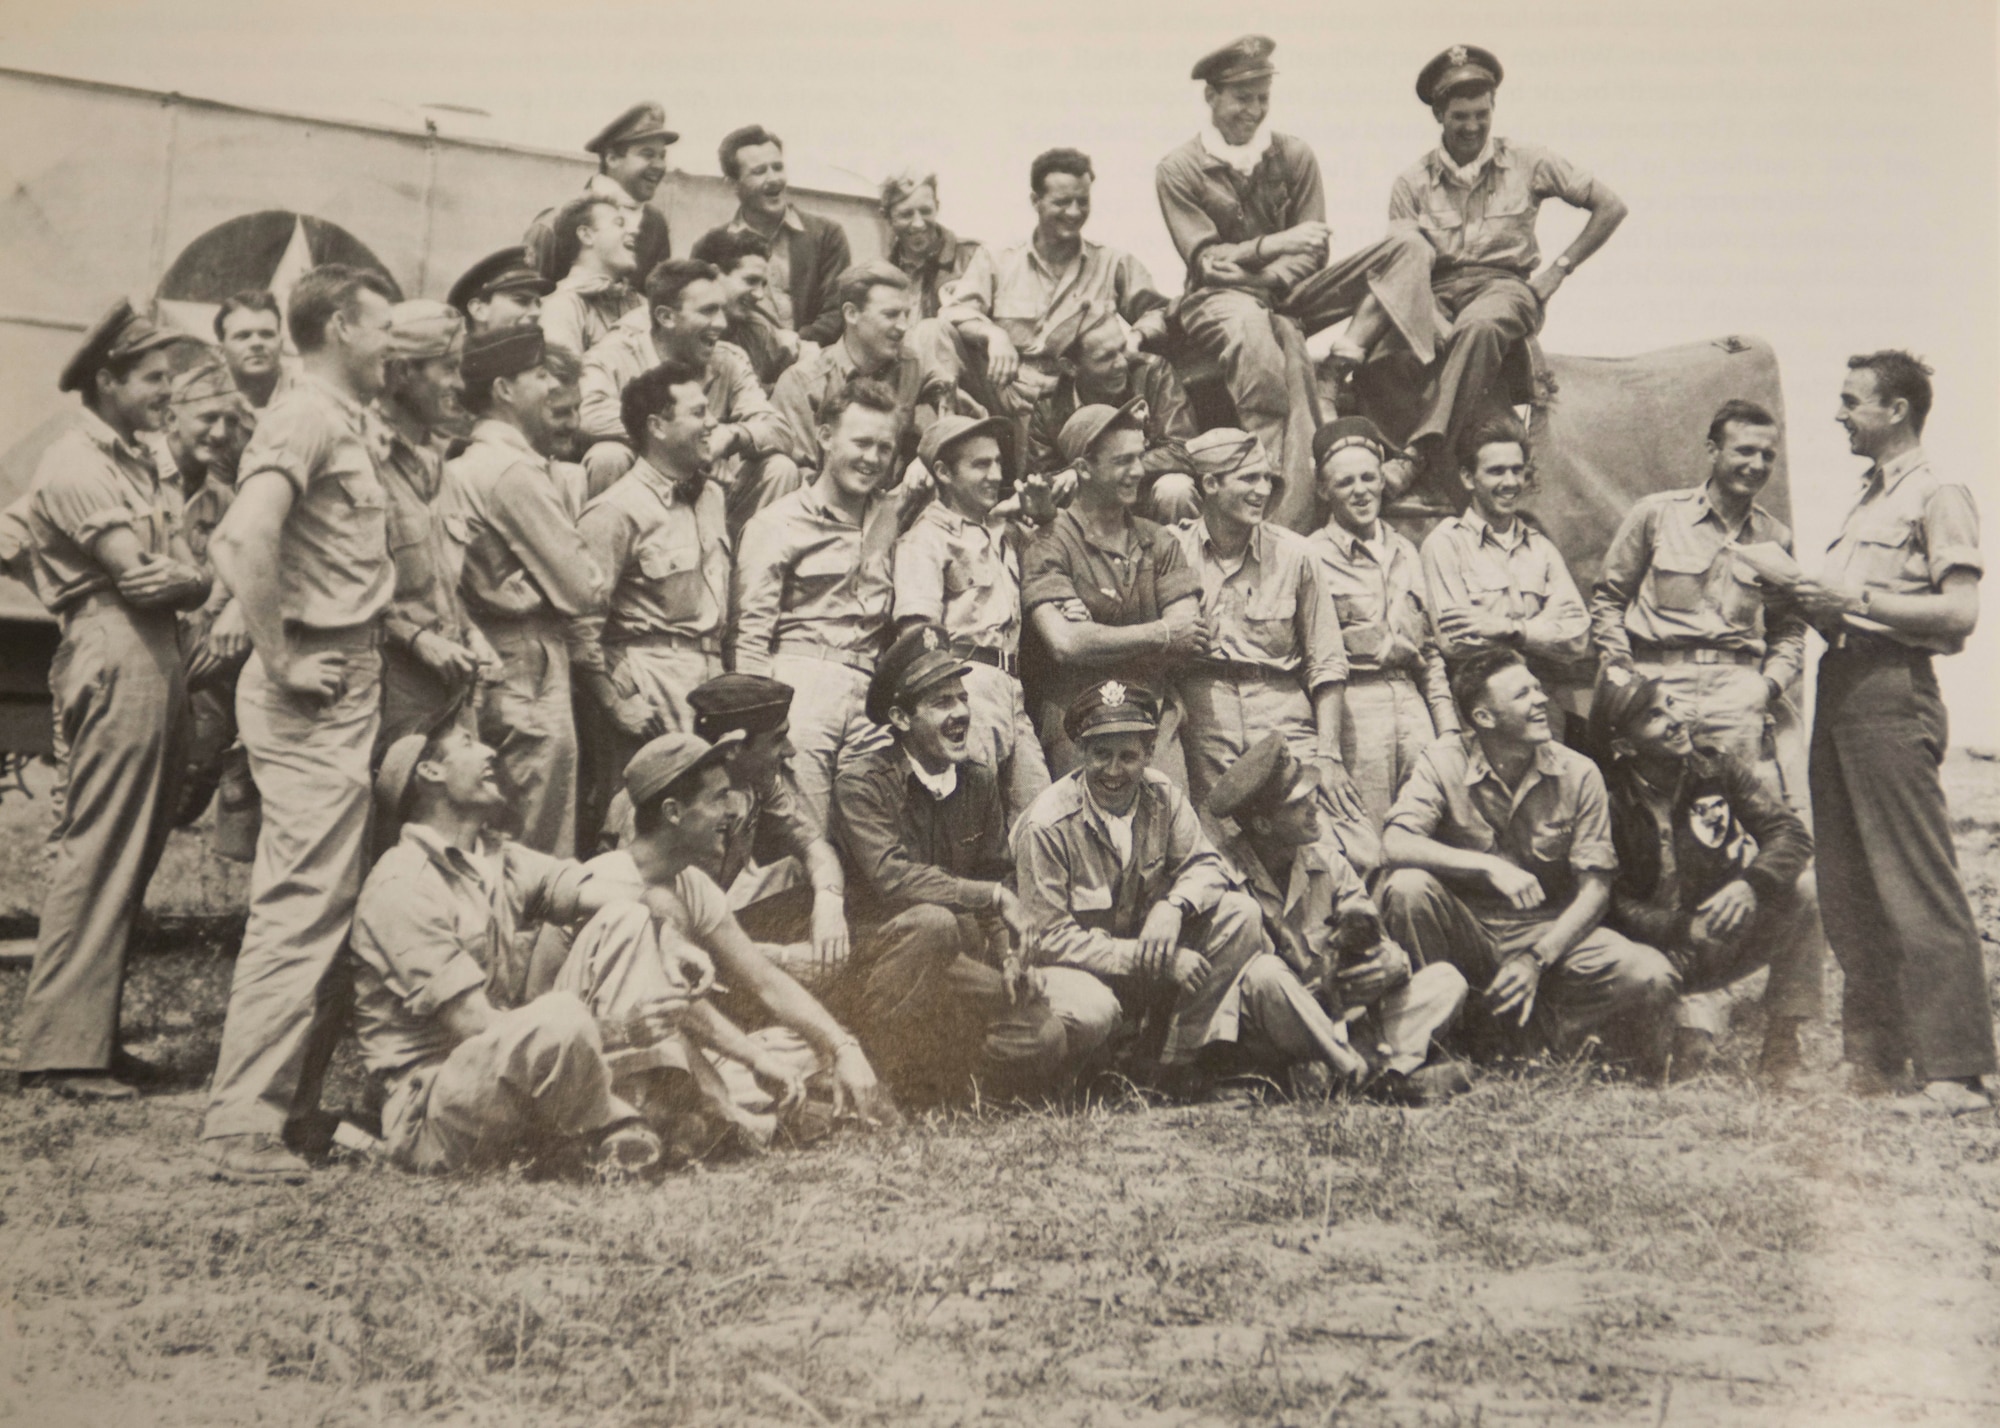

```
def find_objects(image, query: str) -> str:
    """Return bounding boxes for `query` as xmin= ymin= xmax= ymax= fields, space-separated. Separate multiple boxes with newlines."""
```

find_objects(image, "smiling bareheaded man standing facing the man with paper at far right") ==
xmin=1590 ymin=400 xmax=1806 ymax=792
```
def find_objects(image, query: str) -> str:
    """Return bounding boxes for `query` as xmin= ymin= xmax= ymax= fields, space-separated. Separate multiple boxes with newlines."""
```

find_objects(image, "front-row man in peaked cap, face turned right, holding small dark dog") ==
xmin=1208 ymin=734 xmax=1466 ymax=1106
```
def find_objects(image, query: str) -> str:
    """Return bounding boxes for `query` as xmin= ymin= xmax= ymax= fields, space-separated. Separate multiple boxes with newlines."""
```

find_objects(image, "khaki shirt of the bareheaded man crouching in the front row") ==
xmin=1384 ymin=734 xmax=1618 ymax=936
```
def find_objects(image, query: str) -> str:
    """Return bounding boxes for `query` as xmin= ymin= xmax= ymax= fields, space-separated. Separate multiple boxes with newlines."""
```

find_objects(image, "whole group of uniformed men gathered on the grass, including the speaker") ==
xmin=10 ymin=36 xmax=1994 ymax=1178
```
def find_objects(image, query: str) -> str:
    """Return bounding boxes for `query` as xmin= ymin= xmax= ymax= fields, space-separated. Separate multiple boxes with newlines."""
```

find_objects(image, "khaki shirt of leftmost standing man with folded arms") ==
xmin=28 ymin=410 xmax=182 ymax=614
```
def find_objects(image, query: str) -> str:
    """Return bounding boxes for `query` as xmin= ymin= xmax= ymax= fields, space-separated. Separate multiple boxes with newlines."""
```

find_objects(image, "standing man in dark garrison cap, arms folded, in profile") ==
xmin=444 ymin=326 xmax=606 ymax=858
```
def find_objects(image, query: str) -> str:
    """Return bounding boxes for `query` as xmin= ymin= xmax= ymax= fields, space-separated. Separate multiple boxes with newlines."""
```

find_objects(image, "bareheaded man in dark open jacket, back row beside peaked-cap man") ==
xmin=716 ymin=124 xmax=854 ymax=348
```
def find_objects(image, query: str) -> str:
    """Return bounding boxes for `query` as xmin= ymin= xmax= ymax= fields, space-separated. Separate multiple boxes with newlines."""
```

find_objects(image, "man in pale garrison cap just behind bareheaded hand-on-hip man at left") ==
xmin=376 ymin=298 xmax=500 ymax=748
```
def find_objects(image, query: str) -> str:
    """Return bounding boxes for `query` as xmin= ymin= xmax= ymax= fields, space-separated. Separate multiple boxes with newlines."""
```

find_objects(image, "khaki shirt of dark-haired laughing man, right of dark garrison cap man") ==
xmin=576 ymin=458 xmax=730 ymax=670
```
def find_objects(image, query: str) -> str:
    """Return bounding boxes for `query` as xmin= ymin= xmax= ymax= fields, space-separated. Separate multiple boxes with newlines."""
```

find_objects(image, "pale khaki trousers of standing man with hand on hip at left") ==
xmin=202 ymin=626 xmax=382 ymax=1138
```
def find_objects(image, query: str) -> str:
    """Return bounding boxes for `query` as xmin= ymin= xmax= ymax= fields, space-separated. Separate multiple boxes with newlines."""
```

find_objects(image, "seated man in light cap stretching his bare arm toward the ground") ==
xmin=528 ymin=732 xmax=898 ymax=1142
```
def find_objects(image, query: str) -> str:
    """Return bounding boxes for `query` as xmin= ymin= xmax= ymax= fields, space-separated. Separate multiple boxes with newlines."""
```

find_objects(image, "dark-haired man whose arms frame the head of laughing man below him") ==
xmin=582 ymin=258 xmax=798 ymax=516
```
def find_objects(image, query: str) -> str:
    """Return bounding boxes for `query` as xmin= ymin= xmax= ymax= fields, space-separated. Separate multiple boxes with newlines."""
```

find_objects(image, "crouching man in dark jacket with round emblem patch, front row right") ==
xmin=1590 ymin=668 xmax=1822 ymax=1084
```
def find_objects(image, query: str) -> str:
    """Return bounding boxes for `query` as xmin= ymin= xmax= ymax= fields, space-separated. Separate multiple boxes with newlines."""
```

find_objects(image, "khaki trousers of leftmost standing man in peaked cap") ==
xmin=14 ymin=594 xmax=188 ymax=1072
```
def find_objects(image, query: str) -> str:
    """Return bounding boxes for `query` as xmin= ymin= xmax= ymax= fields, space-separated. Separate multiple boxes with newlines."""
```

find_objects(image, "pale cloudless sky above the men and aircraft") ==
xmin=0 ymin=0 xmax=2000 ymax=746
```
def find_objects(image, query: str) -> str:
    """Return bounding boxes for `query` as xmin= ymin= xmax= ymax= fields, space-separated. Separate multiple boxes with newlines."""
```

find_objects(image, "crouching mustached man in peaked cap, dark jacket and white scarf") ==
xmin=834 ymin=620 xmax=1072 ymax=1102
